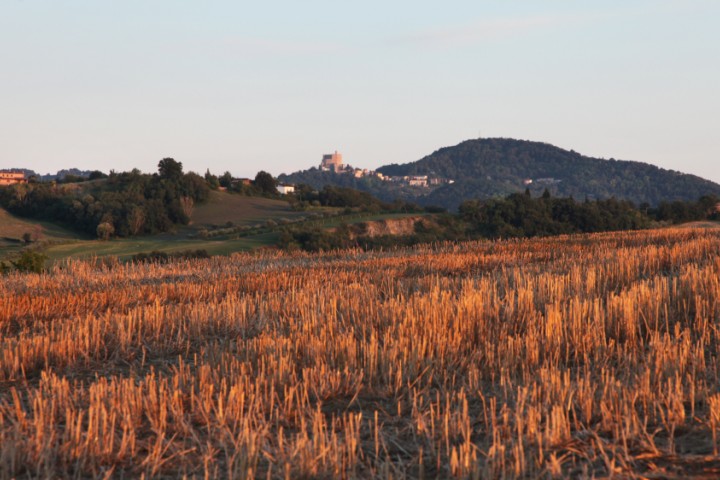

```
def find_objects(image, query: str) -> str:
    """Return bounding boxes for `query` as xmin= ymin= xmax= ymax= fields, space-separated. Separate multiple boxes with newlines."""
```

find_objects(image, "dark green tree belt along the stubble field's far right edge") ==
xmin=279 ymin=190 xmax=720 ymax=251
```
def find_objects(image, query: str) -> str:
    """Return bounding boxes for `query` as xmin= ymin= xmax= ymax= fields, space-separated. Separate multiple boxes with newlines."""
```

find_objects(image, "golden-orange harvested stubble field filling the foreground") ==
xmin=0 ymin=228 xmax=720 ymax=479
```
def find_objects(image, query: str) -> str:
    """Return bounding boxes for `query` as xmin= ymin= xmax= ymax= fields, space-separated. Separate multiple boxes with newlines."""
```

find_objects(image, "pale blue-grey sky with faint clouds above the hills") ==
xmin=0 ymin=0 xmax=720 ymax=182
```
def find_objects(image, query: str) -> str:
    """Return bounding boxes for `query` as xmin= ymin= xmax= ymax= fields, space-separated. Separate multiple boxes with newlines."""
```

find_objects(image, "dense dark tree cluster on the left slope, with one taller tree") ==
xmin=0 ymin=158 xmax=210 ymax=239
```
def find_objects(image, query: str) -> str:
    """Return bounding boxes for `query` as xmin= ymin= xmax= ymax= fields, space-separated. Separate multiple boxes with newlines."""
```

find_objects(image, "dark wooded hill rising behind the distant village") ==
xmin=280 ymin=138 xmax=720 ymax=210
